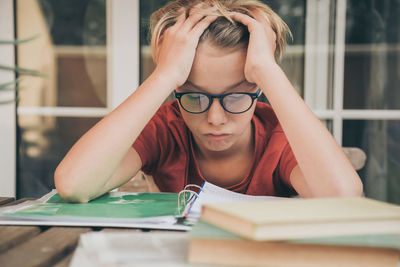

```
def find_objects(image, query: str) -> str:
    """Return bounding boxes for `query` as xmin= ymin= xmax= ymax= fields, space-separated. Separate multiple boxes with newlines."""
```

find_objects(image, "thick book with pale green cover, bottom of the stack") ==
xmin=188 ymin=221 xmax=400 ymax=267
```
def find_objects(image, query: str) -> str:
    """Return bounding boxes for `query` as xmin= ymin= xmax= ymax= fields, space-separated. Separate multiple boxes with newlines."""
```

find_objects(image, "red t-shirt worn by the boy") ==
xmin=133 ymin=101 xmax=297 ymax=196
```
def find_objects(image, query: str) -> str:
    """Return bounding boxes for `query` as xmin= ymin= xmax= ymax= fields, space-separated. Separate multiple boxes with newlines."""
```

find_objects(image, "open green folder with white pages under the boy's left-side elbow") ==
xmin=0 ymin=190 xmax=192 ymax=230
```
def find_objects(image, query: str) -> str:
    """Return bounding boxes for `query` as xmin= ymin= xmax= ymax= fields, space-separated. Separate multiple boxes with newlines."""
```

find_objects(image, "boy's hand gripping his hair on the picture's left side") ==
xmin=155 ymin=4 xmax=217 ymax=88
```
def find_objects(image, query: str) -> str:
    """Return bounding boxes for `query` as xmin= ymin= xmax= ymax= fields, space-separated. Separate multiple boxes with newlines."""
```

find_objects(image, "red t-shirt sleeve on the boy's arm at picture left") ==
xmin=132 ymin=117 xmax=165 ymax=174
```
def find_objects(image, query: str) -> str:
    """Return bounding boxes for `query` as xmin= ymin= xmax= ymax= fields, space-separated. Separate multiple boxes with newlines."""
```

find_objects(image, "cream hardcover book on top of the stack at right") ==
xmin=201 ymin=197 xmax=400 ymax=240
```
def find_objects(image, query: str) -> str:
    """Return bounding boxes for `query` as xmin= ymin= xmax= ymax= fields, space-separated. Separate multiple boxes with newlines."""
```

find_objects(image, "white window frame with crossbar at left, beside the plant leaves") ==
xmin=0 ymin=0 xmax=140 ymax=197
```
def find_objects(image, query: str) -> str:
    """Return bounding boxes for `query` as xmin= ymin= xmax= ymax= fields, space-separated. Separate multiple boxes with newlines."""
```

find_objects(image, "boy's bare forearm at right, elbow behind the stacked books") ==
xmin=257 ymin=64 xmax=362 ymax=196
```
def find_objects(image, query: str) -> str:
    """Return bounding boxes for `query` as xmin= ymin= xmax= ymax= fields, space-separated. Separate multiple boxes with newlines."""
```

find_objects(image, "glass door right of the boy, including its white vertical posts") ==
xmin=305 ymin=0 xmax=400 ymax=203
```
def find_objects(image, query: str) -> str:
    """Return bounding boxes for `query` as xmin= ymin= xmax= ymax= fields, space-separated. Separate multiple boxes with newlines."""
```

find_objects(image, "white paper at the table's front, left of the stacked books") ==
xmin=70 ymin=231 xmax=206 ymax=267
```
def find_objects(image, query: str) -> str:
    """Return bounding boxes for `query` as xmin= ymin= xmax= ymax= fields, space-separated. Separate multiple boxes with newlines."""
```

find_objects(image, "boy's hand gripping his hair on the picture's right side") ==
xmin=231 ymin=11 xmax=276 ymax=83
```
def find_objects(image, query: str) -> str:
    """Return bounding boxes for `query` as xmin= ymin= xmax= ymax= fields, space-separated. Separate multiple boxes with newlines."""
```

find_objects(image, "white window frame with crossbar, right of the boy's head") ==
xmin=304 ymin=0 xmax=400 ymax=145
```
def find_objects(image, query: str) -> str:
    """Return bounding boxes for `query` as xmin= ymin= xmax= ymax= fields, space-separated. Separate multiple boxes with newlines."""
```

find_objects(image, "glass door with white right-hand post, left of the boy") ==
xmin=16 ymin=0 xmax=138 ymax=197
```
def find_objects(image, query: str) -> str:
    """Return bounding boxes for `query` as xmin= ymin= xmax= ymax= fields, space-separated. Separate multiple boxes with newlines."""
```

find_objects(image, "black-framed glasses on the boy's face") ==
xmin=174 ymin=88 xmax=261 ymax=114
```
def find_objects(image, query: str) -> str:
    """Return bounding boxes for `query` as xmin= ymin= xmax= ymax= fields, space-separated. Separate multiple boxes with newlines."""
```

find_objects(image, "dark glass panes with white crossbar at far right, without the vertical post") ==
xmin=342 ymin=0 xmax=400 ymax=204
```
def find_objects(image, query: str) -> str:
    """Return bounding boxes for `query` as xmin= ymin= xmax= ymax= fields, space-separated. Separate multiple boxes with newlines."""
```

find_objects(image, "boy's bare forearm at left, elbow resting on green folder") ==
xmin=54 ymin=73 xmax=173 ymax=202
